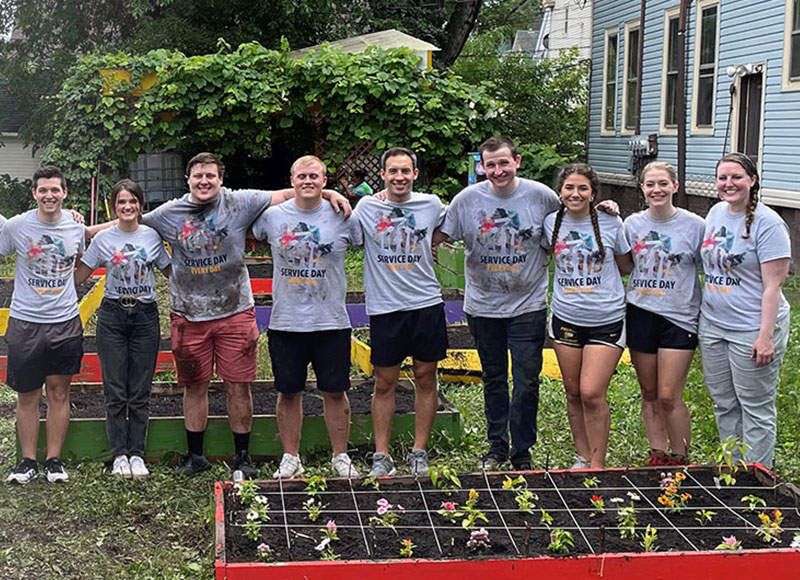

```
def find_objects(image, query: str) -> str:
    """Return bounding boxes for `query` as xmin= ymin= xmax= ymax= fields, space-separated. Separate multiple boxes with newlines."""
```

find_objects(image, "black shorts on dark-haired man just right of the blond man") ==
xmin=369 ymin=303 xmax=447 ymax=367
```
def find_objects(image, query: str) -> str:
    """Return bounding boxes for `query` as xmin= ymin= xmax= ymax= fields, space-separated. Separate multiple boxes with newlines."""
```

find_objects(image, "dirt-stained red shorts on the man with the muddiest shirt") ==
xmin=170 ymin=308 xmax=258 ymax=385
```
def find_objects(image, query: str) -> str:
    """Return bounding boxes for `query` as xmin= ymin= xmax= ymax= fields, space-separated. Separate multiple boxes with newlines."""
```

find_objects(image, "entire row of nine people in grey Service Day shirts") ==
xmin=0 ymin=137 xmax=790 ymax=484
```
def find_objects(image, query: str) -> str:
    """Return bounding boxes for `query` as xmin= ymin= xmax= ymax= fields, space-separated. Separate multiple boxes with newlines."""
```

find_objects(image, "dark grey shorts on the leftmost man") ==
xmin=6 ymin=316 xmax=83 ymax=393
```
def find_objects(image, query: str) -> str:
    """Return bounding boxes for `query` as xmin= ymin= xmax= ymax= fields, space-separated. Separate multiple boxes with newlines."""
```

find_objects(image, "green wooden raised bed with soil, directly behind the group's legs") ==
xmin=10 ymin=380 xmax=463 ymax=460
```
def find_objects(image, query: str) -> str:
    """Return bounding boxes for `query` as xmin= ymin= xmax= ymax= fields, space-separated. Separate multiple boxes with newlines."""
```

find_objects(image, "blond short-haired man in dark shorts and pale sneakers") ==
xmin=253 ymin=155 xmax=361 ymax=478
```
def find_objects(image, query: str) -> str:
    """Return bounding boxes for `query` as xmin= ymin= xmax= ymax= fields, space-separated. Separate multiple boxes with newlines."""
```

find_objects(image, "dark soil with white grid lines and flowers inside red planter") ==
xmin=217 ymin=466 xmax=800 ymax=563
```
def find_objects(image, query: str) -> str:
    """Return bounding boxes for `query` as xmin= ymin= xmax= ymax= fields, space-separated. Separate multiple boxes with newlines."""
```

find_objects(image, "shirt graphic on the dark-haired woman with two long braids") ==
xmin=553 ymin=230 xmax=603 ymax=294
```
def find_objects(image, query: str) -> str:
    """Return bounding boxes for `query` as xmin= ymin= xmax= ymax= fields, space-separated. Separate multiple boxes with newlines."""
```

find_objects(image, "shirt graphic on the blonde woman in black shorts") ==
xmin=631 ymin=230 xmax=683 ymax=296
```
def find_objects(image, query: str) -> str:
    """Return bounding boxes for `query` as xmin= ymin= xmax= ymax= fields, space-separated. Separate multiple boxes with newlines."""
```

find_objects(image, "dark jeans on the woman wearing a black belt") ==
xmin=97 ymin=300 xmax=160 ymax=457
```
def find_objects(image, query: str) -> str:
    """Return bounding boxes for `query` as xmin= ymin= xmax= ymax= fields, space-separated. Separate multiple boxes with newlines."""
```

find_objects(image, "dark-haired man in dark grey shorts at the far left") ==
xmin=0 ymin=165 xmax=86 ymax=484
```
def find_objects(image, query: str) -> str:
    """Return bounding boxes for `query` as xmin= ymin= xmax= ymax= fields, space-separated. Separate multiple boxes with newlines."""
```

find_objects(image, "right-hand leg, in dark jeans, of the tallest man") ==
xmin=506 ymin=310 xmax=547 ymax=467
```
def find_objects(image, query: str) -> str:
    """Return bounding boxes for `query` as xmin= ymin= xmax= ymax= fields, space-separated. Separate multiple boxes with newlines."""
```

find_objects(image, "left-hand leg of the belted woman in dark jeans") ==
xmin=97 ymin=301 xmax=130 ymax=457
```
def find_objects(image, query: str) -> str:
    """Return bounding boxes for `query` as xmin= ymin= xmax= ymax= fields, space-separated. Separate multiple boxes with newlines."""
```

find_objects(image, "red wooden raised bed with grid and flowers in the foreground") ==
xmin=215 ymin=465 xmax=800 ymax=580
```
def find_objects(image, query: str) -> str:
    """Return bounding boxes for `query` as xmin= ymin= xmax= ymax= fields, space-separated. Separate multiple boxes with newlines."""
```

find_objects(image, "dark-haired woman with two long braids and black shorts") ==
xmin=542 ymin=163 xmax=633 ymax=469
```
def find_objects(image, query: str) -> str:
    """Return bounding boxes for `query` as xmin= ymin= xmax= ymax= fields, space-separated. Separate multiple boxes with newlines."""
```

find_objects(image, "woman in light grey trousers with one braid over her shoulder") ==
xmin=699 ymin=153 xmax=791 ymax=468
